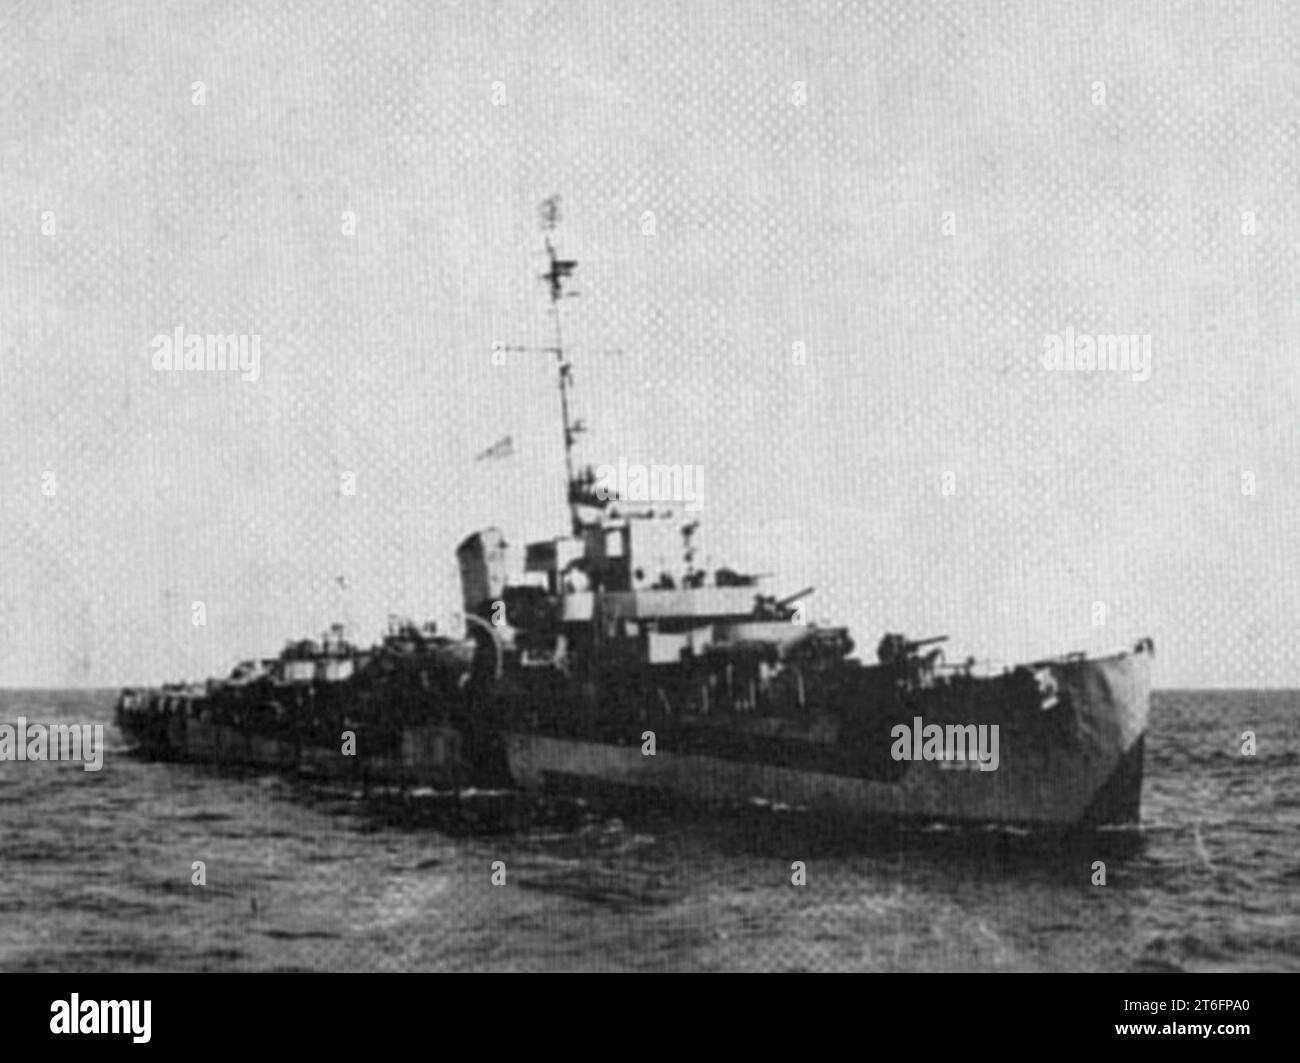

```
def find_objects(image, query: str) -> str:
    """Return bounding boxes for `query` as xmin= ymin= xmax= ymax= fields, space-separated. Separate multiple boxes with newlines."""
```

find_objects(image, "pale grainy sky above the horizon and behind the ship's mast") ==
xmin=0 ymin=0 xmax=1300 ymax=966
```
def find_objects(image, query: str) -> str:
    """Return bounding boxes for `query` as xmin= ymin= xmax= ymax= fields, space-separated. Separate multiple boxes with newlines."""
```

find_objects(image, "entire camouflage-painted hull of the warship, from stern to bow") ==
xmin=118 ymin=636 xmax=1151 ymax=828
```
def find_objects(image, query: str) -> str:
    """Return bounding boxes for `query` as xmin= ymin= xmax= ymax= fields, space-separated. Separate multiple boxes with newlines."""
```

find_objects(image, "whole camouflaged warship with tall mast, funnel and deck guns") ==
xmin=118 ymin=200 xmax=1153 ymax=829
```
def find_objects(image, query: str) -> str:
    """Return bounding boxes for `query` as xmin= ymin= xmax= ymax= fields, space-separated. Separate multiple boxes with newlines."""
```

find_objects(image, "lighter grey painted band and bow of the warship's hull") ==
xmin=506 ymin=636 xmax=1149 ymax=828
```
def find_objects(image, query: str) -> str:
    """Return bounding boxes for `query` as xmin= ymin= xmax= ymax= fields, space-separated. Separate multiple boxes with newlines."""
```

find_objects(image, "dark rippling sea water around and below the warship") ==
xmin=0 ymin=691 xmax=1300 ymax=972
